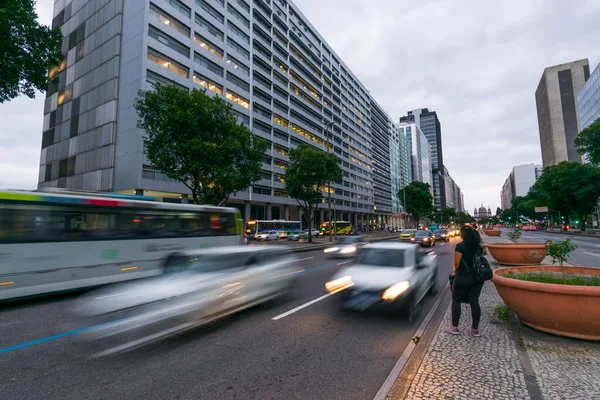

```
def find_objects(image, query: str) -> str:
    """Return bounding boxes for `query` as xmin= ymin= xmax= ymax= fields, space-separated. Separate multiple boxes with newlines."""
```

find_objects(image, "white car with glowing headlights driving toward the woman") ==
xmin=325 ymin=242 xmax=437 ymax=322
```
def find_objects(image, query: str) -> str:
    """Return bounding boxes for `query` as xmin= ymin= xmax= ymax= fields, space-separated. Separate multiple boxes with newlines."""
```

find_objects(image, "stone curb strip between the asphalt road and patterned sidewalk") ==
xmin=374 ymin=282 xmax=451 ymax=400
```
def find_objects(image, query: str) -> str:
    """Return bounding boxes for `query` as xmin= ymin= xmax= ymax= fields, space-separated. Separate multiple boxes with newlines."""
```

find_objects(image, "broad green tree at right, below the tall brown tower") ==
xmin=536 ymin=161 xmax=600 ymax=230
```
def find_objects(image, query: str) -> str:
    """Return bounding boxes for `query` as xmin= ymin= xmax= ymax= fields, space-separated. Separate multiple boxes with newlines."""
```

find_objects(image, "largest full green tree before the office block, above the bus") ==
xmin=134 ymin=84 xmax=267 ymax=205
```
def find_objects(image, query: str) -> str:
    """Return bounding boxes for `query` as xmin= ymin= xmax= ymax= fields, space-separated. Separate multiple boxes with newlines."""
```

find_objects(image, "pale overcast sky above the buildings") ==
xmin=0 ymin=0 xmax=600 ymax=213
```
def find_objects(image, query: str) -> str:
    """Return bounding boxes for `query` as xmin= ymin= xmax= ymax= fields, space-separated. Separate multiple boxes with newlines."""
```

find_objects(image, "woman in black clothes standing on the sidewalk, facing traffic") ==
xmin=446 ymin=225 xmax=483 ymax=336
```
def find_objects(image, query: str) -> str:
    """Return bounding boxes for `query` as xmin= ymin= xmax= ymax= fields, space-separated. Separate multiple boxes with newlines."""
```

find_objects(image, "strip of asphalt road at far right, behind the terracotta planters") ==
xmin=520 ymin=231 xmax=600 ymax=267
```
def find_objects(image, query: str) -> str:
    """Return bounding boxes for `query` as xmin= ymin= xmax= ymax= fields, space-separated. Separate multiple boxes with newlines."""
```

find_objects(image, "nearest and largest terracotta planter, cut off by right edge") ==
xmin=493 ymin=265 xmax=600 ymax=340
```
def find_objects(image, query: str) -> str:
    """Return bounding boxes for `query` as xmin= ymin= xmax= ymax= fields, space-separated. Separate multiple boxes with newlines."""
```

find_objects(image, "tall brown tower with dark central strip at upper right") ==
xmin=535 ymin=59 xmax=590 ymax=167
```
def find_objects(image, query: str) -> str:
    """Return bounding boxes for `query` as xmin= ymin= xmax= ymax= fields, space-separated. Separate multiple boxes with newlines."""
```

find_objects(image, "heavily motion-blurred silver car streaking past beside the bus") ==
xmin=76 ymin=246 xmax=300 ymax=355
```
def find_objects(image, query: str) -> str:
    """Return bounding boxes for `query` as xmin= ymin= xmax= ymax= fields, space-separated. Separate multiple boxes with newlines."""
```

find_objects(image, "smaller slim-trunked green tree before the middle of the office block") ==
xmin=284 ymin=144 xmax=343 ymax=242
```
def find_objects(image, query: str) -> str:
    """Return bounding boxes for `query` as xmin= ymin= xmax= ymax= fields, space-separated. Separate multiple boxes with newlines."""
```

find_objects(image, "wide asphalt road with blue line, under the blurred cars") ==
xmin=0 ymin=238 xmax=459 ymax=400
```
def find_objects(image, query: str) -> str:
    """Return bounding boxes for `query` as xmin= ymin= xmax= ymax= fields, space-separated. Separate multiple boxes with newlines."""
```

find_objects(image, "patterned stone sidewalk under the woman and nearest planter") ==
xmin=388 ymin=237 xmax=600 ymax=400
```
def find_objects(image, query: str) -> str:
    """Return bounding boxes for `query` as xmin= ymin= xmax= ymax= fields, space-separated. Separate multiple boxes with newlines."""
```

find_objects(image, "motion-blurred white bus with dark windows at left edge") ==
xmin=0 ymin=191 xmax=243 ymax=300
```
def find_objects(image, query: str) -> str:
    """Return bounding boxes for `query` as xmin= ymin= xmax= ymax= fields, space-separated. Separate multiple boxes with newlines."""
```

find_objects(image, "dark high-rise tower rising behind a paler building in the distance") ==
xmin=400 ymin=108 xmax=446 ymax=211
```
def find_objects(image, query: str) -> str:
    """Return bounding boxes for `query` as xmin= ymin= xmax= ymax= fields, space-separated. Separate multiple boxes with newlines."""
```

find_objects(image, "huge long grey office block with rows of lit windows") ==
xmin=38 ymin=0 xmax=403 ymax=226
